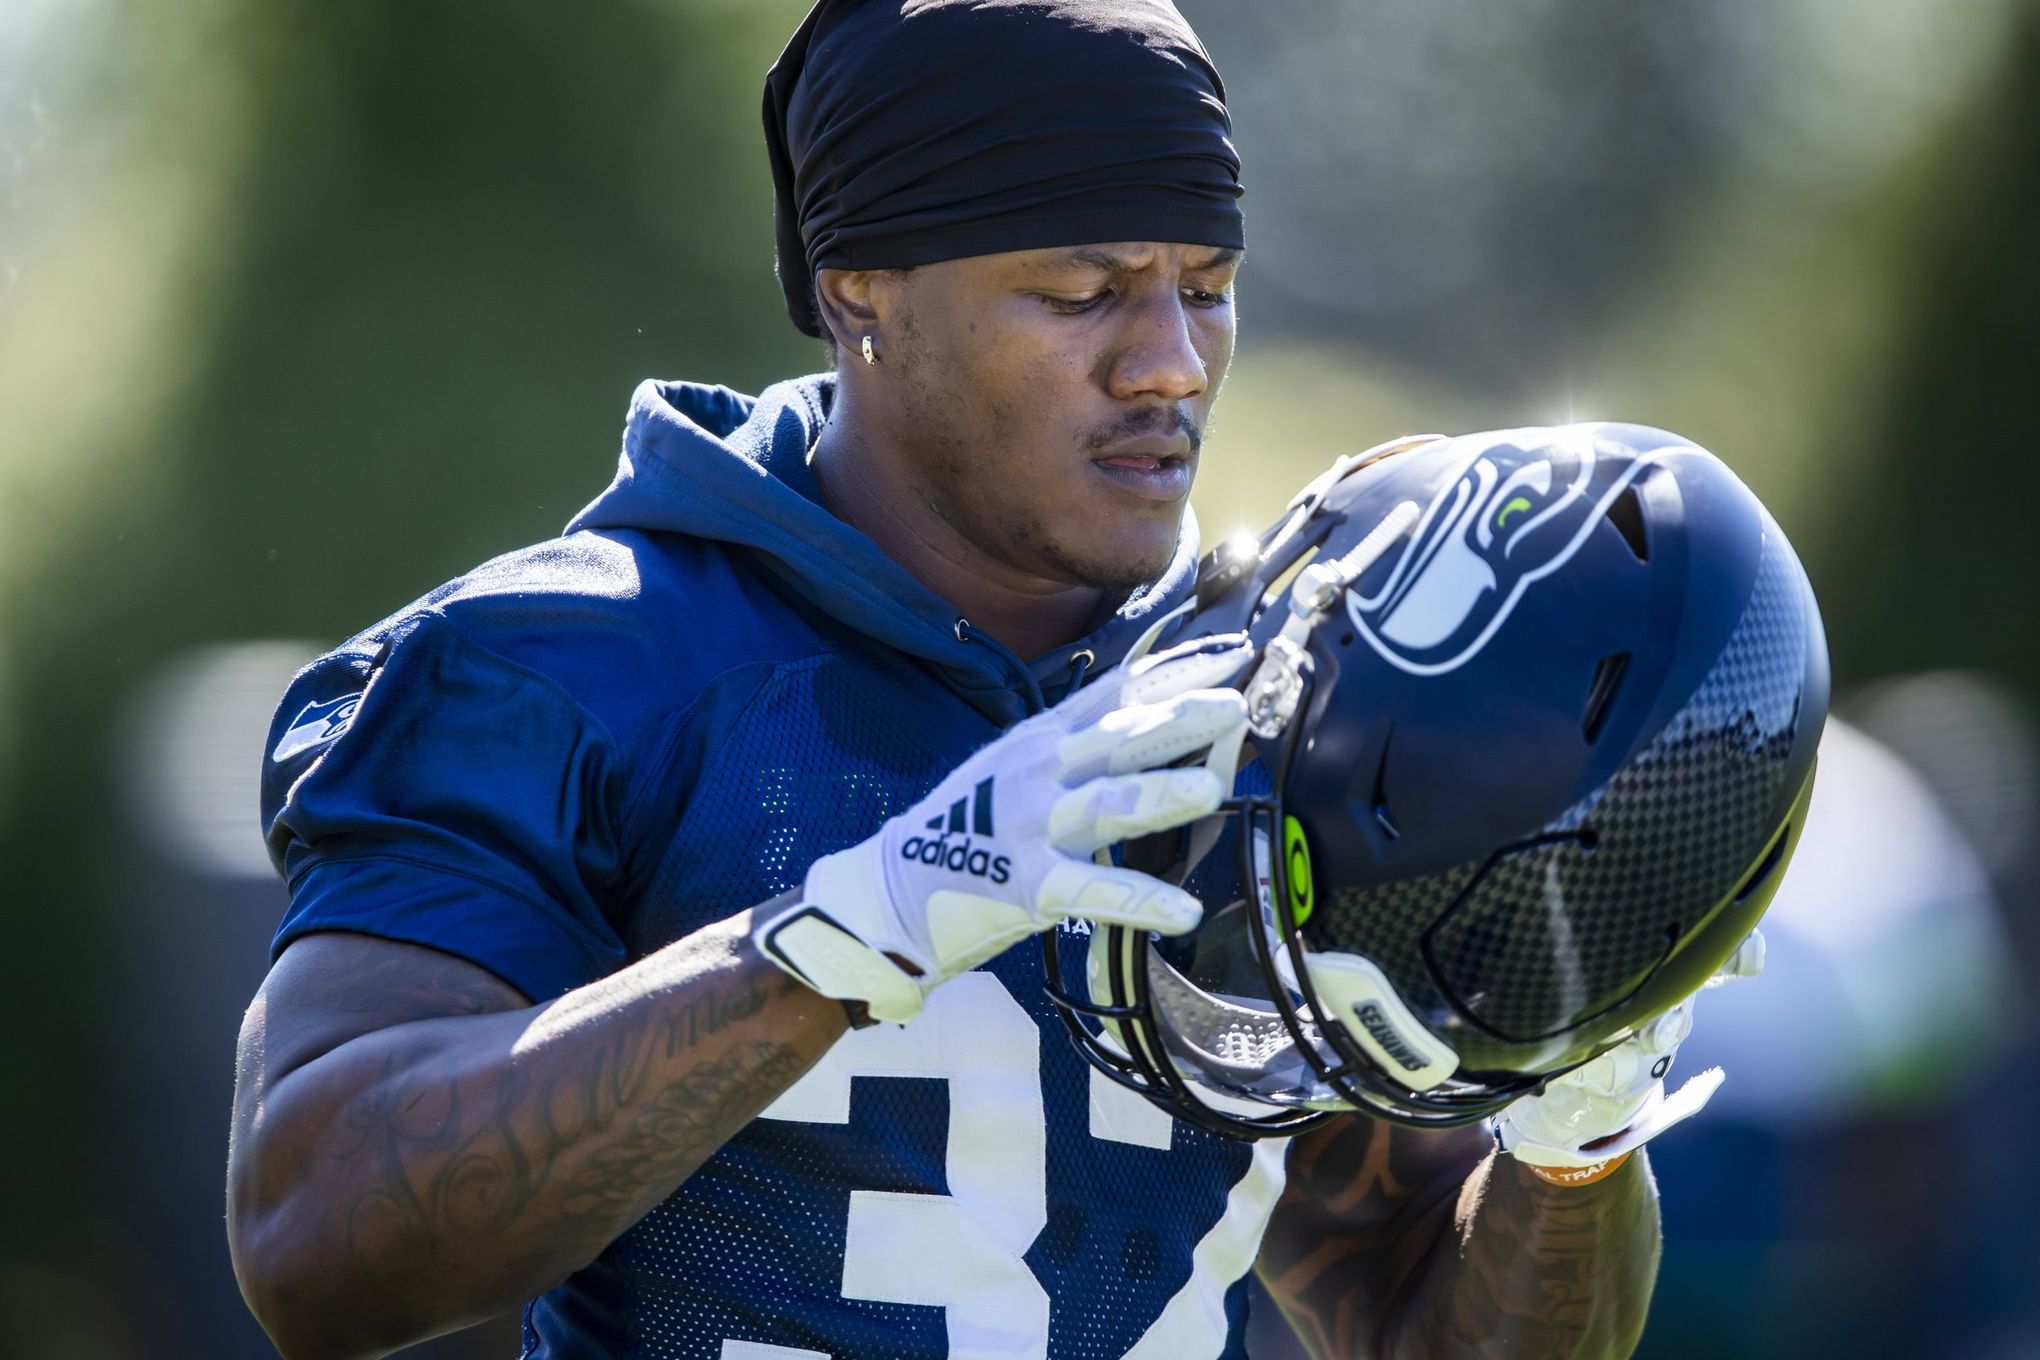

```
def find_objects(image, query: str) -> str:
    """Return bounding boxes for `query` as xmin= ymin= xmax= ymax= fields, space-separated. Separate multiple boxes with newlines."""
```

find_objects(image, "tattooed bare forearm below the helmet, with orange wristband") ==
xmin=1261 ymin=1117 xmax=1659 ymax=1360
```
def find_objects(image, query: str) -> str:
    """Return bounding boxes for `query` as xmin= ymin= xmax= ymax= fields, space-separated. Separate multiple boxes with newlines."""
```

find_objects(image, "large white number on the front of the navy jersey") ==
xmin=750 ymin=973 xmax=1283 ymax=1360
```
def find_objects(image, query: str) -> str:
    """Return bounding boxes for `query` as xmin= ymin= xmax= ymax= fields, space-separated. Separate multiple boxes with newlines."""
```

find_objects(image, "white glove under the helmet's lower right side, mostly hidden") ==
xmin=1493 ymin=930 xmax=1765 ymax=1181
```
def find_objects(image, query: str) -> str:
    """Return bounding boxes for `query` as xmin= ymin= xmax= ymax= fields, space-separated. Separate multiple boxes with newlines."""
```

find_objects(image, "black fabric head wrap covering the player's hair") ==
xmin=765 ymin=0 xmax=1246 ymax=336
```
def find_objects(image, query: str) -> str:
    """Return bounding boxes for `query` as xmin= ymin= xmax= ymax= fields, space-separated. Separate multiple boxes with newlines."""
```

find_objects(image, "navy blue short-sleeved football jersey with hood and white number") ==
xmin=263 ymin=379 xmax=1281 ymax=1360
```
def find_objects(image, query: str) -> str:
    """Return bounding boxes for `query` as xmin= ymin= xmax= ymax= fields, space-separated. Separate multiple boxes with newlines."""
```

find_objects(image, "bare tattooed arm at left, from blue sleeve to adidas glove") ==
xmin=226 ymin=913 xmax=847 ymax=1360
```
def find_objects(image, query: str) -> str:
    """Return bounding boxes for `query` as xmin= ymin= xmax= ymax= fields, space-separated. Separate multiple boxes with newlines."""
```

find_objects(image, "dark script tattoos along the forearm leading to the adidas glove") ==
xmin=326 ymin=958 xmax=814 ymax=1295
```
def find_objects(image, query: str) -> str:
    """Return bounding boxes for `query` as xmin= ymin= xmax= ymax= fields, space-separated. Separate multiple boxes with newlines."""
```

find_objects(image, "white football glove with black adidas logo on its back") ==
xmin=753 ymin=634 xmax=1253 ymax=1022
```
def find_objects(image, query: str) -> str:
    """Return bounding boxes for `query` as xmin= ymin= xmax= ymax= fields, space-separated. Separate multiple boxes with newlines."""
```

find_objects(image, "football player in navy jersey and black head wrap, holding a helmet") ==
xmin=228 ymin=0 xmax=1827 ymax=1360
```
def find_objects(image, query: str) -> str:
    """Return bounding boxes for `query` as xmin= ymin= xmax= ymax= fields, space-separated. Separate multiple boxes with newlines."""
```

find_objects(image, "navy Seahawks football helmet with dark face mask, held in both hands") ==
xmin=1042 ymin=424 xmax=1828 ymax=1138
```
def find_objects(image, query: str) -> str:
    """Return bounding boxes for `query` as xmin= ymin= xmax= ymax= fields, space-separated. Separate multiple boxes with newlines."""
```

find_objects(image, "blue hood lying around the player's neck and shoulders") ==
xmin=567 ymin=373 xmax=1197 ymax=724
